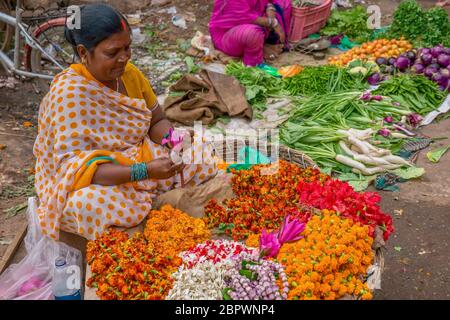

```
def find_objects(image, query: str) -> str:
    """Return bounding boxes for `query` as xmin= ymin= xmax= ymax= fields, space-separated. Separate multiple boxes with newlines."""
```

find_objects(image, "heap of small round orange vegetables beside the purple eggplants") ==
xmin=328 ymin=39 xmax=413 ymax=66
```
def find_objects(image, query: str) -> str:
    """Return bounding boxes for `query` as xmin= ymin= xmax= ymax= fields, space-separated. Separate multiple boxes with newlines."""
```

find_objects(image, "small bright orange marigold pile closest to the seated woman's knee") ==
xmin=144 ymin=205 xmax=211 ymax=254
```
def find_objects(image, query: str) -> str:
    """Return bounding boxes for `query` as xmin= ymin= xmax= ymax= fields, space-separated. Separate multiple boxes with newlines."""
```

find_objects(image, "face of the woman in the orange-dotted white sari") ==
xmin=78 ymin=30 xmax=131 ymax=83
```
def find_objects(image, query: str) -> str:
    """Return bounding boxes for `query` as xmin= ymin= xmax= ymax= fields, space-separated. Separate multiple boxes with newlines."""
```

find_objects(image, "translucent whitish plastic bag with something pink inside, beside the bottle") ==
xmin=0 ymin=198 xmax=82 ymax=300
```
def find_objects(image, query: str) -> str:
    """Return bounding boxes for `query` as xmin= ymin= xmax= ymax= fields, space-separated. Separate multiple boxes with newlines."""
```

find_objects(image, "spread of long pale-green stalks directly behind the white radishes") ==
xmin=280 ymin=91 xmax=411 ymax=172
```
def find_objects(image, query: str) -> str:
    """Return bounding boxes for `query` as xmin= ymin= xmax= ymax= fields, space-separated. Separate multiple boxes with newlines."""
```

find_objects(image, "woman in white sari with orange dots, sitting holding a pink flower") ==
xmin=34 ymin=4 xmax=216 ymax=239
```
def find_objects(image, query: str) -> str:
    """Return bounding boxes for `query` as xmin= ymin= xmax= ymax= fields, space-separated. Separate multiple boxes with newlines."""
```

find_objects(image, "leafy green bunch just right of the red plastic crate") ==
xmin=320 ymin=6 xmax=372 ymax=43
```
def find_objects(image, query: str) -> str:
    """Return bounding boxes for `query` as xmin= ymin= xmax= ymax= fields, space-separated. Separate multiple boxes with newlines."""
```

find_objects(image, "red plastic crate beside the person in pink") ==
xmin=289 ymin=0 xmax=333 ymax=42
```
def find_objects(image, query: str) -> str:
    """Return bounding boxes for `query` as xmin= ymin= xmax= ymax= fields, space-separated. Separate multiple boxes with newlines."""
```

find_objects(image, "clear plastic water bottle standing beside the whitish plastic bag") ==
xmin=52 ymin=257 xmax=81 ymax=300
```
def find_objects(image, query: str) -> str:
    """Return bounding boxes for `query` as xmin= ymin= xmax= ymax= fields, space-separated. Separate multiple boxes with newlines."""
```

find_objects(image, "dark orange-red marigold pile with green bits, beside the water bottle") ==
xmin=87 ymin=229 xmax=182 ymax=300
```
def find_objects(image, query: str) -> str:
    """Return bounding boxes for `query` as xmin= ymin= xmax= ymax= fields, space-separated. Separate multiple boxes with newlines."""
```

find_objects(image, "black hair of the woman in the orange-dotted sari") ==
xmin=64 ymin=3 xmax=130 ymax=55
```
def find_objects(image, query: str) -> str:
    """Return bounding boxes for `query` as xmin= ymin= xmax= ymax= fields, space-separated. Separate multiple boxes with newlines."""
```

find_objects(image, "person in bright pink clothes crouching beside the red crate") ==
xmin=209 ymin=0 xmax=292 ymax=66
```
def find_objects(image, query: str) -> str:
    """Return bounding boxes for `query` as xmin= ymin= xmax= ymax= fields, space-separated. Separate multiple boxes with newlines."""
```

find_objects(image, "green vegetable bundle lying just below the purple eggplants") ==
xmin=374 ymin=75 xmax=446 ymax=115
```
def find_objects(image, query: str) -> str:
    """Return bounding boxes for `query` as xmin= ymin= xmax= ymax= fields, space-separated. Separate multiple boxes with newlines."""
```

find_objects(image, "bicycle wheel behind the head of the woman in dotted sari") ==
xmin=25 ymin=18 xmax=76 ymax=75
